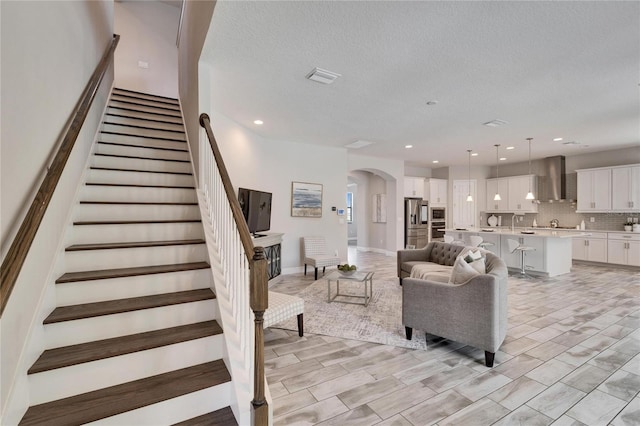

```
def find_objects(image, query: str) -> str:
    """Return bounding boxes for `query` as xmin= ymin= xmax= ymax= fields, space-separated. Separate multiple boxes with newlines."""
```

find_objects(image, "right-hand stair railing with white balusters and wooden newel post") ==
xmin=200 ymin=114 xmax=269 ymax=426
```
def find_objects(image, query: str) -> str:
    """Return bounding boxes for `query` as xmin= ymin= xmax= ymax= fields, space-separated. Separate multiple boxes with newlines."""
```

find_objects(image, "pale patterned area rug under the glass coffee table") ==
xmin=273 ymin=277 xmax=427 ymax=349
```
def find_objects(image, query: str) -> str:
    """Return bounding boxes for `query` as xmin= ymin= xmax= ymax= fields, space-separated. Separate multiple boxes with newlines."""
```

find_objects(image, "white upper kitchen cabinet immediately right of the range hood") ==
xmin=576 ymin=168 xmax=611 ymax=213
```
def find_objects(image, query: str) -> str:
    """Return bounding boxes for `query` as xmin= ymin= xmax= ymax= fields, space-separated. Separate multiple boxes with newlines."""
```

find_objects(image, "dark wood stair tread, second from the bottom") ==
xmin=20 ymin=360 xmax=231 ymax=426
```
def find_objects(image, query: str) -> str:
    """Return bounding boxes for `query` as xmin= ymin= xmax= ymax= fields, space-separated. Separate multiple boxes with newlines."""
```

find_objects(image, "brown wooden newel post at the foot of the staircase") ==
xmin=249 ymin=247 xmax=269 ymax=426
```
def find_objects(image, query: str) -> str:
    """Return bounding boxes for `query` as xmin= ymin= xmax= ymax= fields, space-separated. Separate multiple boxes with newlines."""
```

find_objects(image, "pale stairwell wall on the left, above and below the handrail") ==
xmin=0 ymin=0 xmax=113 ymax=424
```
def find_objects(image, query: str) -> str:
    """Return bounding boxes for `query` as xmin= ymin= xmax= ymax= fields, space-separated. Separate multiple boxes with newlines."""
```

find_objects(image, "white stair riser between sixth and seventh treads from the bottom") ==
xmin=66 ymin=222 xmax=204 ymax=246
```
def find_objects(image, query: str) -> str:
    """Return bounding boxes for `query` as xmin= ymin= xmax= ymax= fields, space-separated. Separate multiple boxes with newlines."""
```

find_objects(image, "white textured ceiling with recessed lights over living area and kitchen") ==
xmin=203 ymin=0 xmax=640 ymax=167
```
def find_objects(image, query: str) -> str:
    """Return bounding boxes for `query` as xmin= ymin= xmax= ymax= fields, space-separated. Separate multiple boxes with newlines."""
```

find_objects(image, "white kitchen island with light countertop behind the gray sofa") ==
xmin=445 ymin=227 xmax=589 ymax=277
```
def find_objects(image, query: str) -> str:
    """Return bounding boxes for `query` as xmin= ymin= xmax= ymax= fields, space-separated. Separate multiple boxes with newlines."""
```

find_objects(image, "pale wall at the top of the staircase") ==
xmin=114 ymin=1 xmax=180 ymax=98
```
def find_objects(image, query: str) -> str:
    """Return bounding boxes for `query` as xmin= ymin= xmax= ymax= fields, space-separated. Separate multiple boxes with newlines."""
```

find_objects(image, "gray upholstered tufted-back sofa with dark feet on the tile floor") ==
xmin=398 ymin=242 xmax=508 ymax=367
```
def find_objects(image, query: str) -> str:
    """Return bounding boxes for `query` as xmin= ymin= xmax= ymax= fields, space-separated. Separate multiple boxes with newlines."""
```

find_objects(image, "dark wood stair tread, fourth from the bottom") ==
xmin=43 ymin=288 xmax=216 ymax=324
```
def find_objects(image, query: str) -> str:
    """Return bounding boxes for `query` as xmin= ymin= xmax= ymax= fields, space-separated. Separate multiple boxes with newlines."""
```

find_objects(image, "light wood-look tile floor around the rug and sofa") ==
xmin=265 ymin=247 xmax=640 ymax=426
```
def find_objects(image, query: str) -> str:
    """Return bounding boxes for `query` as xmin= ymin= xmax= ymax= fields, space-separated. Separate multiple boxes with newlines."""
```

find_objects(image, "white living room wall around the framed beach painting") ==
xmin=209 ymin=112 xmax=347 ymax=273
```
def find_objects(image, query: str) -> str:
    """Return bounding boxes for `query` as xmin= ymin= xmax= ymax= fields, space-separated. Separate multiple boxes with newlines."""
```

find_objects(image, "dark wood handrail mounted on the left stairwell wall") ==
xmin=0 ymin=34 xmax=120 ymax=316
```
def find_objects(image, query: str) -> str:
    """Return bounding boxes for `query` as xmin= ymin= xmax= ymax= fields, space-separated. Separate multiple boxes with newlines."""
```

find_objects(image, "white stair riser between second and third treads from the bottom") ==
xmin=29 ymin=334 xmax=224 ymax=405
